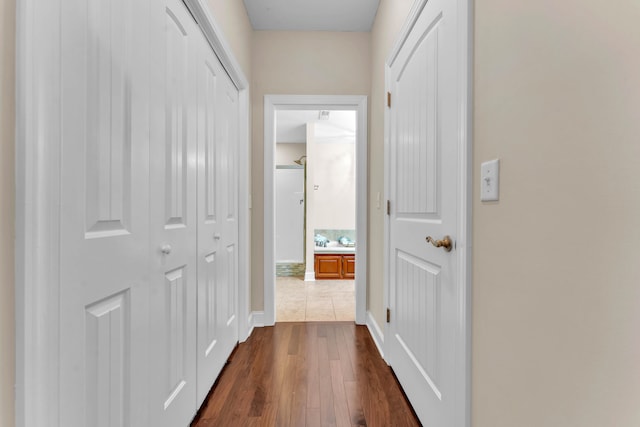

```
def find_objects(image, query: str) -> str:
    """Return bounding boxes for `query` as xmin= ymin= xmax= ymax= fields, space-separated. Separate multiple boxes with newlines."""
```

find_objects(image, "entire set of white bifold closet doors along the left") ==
xmin=55 ymin=0 xmax=239 ymax=427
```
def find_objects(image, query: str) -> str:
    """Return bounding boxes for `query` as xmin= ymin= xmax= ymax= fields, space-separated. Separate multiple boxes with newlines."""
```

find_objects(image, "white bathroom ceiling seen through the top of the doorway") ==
xmin=276 ymin=110 xmax=356 ymax=143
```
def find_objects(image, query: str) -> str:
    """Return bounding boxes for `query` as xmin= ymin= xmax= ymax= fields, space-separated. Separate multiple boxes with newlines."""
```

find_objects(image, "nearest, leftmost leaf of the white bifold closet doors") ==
xmin=58 ymin=0 xmax=149 ymax=427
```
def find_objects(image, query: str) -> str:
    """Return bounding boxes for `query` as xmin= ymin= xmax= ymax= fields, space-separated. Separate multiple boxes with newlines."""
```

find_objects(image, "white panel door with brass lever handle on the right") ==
xmin=387 ymin=0 xmax=465 ymax=427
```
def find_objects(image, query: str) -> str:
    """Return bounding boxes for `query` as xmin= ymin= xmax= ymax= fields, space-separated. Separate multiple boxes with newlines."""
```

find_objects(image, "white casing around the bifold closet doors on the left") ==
xmin=15 ymin=0 xmax=251 ymax=427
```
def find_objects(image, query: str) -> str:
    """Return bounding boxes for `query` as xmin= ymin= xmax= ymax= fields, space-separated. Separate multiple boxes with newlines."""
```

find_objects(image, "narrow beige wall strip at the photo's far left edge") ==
xmin=0 ymin=0 xmax=16 ymax=427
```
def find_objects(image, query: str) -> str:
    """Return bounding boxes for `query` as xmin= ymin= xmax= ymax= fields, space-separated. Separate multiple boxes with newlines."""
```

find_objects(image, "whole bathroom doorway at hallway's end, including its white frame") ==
xmin=264 ymin=95 xmax=367 ymax=325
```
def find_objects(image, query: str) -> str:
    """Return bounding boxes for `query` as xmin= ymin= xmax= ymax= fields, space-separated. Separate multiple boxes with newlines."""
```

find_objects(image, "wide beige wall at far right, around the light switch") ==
xmin=472 ymin=0 xmax=640 ymax=427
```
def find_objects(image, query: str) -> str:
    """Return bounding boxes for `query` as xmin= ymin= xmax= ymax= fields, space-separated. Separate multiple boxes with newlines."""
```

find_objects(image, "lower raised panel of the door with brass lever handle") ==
xmin=395 ymin=252 xmax=442 ymax=399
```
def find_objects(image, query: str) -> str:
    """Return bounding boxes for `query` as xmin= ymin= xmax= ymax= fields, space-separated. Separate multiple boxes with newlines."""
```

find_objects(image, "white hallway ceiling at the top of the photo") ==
xmin=244 ymin=0 xmax=380 ymax=32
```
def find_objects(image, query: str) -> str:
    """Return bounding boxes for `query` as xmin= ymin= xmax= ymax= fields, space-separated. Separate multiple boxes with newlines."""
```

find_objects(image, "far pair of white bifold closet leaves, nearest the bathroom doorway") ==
xmin=197 ymin=35 xmax=239 ymax=406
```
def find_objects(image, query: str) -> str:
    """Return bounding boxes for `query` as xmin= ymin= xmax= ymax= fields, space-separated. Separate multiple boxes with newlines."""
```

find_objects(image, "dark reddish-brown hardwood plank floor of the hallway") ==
xmin=191 ymin=322 xmax=420 ymax=427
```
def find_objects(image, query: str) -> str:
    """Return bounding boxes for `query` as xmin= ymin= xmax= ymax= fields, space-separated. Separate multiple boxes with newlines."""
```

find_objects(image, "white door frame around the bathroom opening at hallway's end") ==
xmin=264 ymin=95 xmax=368 ymax=325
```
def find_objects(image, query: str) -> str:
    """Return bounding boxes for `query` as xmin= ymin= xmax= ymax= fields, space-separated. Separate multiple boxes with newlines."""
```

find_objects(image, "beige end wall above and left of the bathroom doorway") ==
xmin=251 ymin=31 xmax=371 ymax=310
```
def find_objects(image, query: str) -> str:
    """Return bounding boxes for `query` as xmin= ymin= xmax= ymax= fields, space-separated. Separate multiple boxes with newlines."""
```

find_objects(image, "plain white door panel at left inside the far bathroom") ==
xmin=275 ymin=167 xmax=304 ymax=263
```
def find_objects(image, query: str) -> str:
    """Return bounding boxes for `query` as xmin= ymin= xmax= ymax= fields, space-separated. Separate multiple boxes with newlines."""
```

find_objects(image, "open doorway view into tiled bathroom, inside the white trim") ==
xmin=275 ymin=110 xmax=356 ymax=322
